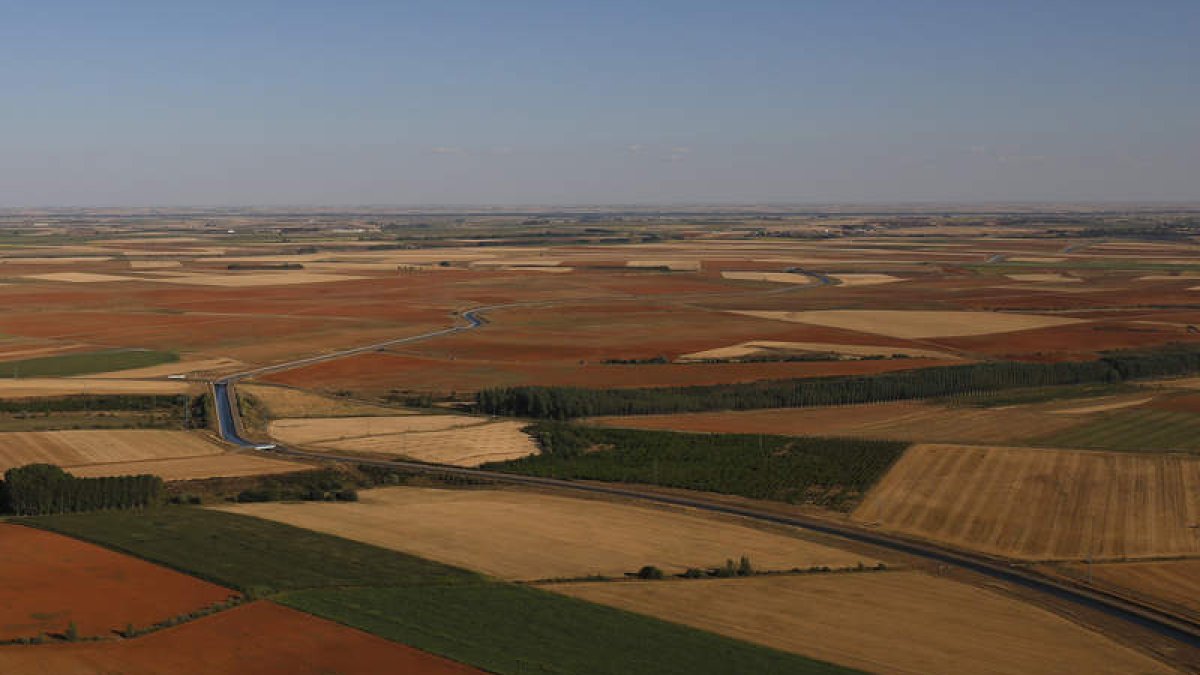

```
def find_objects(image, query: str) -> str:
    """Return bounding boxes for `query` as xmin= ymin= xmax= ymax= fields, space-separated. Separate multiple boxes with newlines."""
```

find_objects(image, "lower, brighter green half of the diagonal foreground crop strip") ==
xmin=281 ymin=584 xmax=853 ymax=675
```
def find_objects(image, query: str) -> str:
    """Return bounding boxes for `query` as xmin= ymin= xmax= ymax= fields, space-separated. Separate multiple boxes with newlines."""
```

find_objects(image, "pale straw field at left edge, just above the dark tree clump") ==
xmin=0 ymin=429 xmax=223 ymax=470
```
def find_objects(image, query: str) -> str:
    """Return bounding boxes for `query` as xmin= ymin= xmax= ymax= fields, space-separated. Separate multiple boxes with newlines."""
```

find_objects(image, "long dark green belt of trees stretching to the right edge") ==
xmin=475 ymin=345 xmax=1200 ymax=419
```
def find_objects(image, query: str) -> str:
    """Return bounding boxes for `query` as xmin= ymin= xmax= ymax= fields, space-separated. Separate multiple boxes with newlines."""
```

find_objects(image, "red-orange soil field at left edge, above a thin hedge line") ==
xmin=0 ymin=524 xmax=235 ymax=638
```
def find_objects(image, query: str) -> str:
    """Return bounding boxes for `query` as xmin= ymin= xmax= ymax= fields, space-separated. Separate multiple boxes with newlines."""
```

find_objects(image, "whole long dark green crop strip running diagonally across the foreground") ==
xmin=19 ymin=507 xmax=857 ymax=675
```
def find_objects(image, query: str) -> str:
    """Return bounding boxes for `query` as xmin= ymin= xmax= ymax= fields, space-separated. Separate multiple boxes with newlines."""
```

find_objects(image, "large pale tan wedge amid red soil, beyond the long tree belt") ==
xmin=733 ymin=310 xmax=1084 ymax=339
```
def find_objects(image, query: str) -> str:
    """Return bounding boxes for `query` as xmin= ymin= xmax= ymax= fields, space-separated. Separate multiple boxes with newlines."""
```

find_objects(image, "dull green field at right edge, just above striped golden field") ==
xmin=1030 ymin=408 xmax=1200 ymax=452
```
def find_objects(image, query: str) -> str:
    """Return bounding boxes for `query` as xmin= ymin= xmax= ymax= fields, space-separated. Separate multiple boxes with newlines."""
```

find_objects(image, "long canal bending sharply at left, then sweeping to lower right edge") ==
xmin=212 ymin=300 xmax=1200 ymax=662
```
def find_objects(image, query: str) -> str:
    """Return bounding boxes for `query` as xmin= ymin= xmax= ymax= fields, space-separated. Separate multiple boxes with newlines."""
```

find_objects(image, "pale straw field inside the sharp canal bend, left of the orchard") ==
xmin=268 ymin=414 xmax=538 ymax=466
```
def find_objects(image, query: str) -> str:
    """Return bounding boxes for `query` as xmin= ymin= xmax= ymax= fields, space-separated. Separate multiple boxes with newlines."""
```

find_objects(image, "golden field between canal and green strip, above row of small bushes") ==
xmin=220 ymin=488 xmax=876 ymax=579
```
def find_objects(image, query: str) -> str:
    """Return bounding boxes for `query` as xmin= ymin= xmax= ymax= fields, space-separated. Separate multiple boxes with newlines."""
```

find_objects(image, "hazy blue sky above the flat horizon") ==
xmin=0 ymin=0 xmax=1200 ymax=207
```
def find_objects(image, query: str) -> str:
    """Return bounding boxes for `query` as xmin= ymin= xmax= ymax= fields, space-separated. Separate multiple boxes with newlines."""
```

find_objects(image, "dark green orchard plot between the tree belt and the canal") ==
xmin=486 ymin=423 xmax=908 ymax=508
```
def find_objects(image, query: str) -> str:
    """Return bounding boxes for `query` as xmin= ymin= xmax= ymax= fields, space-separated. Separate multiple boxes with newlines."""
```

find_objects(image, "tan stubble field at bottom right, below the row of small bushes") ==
xmin=550 ymin=572 xmax=1174 ymax=675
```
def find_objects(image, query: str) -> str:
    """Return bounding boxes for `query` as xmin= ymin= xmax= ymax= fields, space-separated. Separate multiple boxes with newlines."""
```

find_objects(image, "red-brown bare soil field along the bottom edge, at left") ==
xmin=0 ymin=601 xmax=482 ymax=675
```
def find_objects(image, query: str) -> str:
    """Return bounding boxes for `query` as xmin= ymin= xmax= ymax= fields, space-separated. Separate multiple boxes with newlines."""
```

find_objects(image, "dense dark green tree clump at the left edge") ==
xmin=0 ymin=464 xmax=163 ymax=515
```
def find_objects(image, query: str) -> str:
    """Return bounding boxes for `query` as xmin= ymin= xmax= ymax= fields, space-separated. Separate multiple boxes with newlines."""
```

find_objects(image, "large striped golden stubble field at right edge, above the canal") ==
xmin=853 ymin=444 xmax=1200 ymax=560
